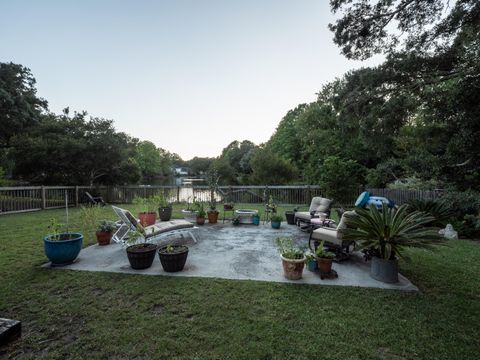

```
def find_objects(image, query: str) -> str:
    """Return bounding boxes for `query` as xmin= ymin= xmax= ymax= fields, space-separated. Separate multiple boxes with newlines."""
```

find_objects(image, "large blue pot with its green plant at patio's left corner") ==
xmin=43 ymin=218 xmax=83 ymax=266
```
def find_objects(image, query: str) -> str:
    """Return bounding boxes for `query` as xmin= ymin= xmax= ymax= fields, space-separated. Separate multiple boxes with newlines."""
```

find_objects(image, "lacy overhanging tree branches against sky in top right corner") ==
xmin=330 ymin=0 xmax=480 ymax=59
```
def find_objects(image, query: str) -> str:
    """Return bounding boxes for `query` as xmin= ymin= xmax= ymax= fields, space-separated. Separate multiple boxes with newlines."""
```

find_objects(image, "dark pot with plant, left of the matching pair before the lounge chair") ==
xmin=126 ymin=226 xmax=157 ymax=270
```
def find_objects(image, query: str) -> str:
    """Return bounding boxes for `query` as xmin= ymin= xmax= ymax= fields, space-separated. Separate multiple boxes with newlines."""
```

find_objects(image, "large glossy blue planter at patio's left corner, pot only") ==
xmin=43 ymin=233 xmax=83 ymax=265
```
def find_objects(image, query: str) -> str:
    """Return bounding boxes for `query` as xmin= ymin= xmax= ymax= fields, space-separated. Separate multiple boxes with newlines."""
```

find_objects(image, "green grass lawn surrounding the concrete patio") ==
xmin=0 ymin=205 xmax=480 ymax=359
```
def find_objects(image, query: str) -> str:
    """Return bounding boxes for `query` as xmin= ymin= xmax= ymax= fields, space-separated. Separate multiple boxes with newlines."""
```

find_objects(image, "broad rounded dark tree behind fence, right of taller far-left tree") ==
xmin=12 ymin=111 xmax=140 ymax=185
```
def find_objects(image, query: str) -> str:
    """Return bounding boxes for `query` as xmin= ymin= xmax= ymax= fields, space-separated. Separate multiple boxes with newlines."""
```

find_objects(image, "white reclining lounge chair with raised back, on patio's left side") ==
xmin=112 ymin=205 xmax=197 ymax=246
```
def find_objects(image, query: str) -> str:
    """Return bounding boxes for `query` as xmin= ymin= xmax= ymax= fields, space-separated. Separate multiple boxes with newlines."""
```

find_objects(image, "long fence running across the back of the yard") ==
xmin=0 ymin=185 xmax=442 ymax=214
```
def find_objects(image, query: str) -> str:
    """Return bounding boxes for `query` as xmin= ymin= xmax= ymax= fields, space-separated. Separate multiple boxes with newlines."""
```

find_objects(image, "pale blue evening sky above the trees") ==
xmin=0 ymin=0 xmax=382 ymax=160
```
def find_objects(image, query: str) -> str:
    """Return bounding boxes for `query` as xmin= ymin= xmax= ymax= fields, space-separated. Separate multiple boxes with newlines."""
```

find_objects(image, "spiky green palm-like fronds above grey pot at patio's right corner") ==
xmin=339 ymin=204 xmax=442 ymax=260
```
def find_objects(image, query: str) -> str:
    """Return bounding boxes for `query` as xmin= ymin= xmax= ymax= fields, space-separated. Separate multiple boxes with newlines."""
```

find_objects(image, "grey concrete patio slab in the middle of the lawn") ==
xmin=44 ymin=223 xmax=418 ymax=291
